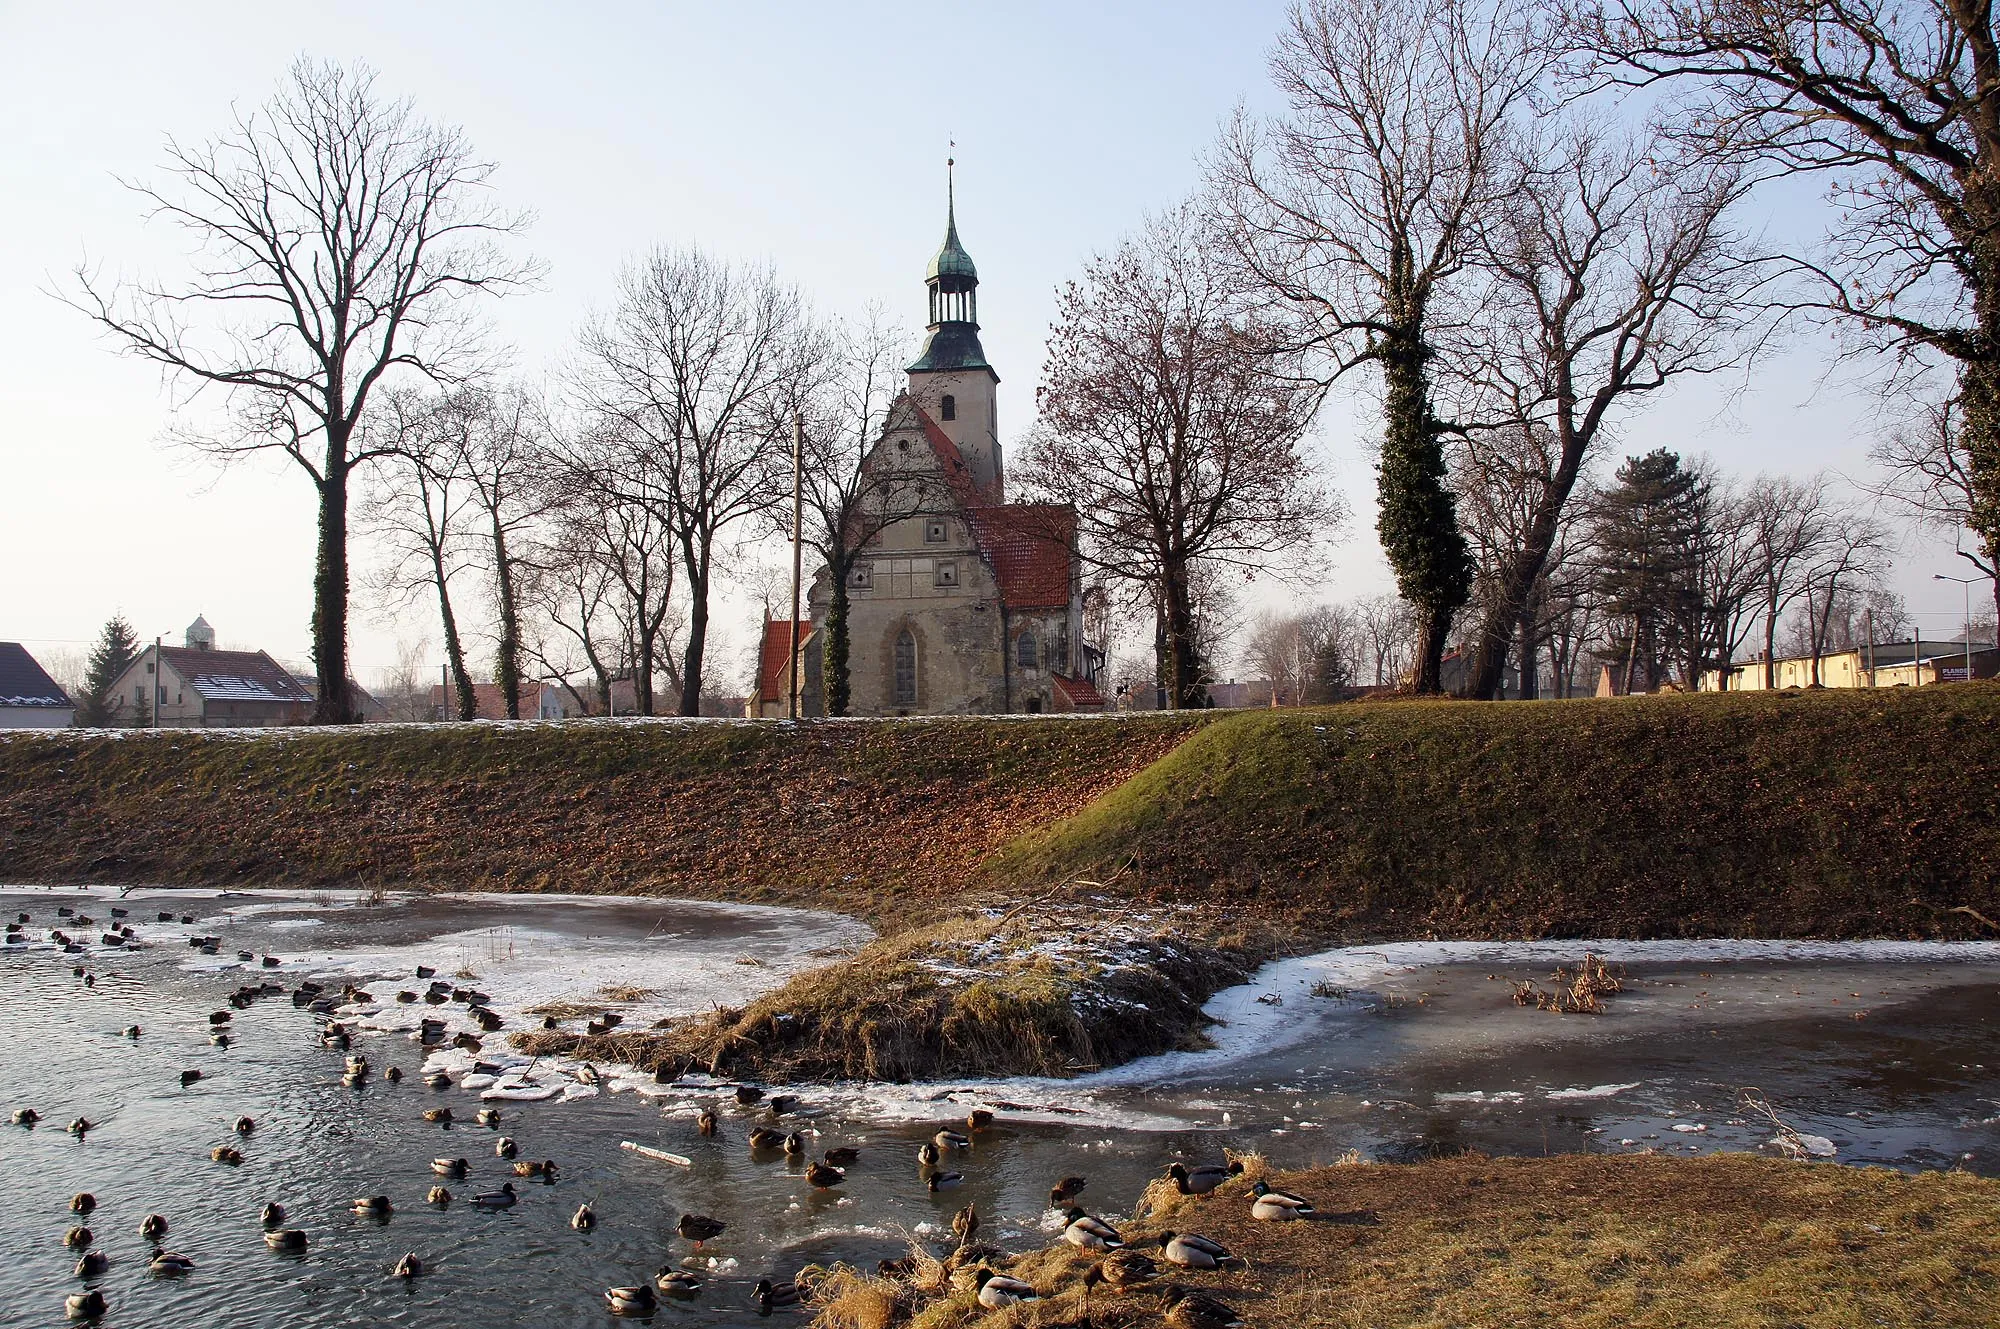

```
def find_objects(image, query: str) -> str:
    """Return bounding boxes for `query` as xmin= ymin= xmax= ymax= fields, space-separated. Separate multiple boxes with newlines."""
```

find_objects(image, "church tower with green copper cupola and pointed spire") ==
xmin=910 ymin=160 xmax=1006 ymax=502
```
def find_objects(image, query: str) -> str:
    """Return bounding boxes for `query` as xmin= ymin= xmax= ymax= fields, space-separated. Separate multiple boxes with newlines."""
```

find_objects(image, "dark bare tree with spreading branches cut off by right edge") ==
xmin=1576 ymin=0 xmax=2000 ymax=624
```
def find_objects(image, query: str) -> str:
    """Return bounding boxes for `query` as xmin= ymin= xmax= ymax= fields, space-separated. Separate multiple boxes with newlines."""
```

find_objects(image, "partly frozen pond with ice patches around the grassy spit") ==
xmin=0 ymin=889 xmax=2000 ymax=1329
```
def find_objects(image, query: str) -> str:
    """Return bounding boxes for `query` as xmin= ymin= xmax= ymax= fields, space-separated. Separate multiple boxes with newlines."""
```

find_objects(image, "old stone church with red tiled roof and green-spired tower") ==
xmin=750 ymin=175 xmax=1104 ymax=717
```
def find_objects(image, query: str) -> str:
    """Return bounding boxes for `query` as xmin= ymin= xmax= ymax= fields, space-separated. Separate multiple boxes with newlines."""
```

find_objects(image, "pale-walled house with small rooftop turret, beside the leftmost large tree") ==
xmin=112 ymin=616 xmax=312 ymax=729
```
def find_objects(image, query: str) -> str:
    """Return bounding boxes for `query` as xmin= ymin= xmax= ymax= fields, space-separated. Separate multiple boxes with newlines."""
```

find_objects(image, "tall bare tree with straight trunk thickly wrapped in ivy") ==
xmin=1212 ymin=0 xmax=1546 ymax=693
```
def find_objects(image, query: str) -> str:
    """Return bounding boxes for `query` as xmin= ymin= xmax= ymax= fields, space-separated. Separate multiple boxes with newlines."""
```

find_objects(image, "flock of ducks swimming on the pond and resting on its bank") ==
xmin=19 ymin=907 xmax=1314 ymax=1329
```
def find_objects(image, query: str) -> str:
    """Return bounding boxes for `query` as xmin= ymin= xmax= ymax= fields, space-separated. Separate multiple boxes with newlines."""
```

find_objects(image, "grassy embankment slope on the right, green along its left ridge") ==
xmin=992 ymin=685 xmax=2000 ymax=937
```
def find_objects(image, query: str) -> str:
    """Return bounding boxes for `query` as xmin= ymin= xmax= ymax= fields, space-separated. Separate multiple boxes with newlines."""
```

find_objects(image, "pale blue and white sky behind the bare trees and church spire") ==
xmin=0 ymin=0 xmax=1984 ymax=683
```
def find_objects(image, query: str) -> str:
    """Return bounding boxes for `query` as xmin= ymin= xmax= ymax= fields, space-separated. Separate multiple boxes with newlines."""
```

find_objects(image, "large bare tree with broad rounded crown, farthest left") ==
xmin=72 ymin=58 xmax=534 ymax=723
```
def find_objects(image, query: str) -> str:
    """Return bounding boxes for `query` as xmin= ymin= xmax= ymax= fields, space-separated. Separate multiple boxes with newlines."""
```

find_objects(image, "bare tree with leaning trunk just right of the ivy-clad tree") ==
xmin=1452 ymin=114 xmax=1758 ymax=699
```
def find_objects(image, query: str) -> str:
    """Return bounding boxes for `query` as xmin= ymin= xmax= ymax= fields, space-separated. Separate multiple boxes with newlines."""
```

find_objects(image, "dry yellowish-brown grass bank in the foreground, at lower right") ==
xmin=814 ymin=1155 xmax=2000 ymax=1329
